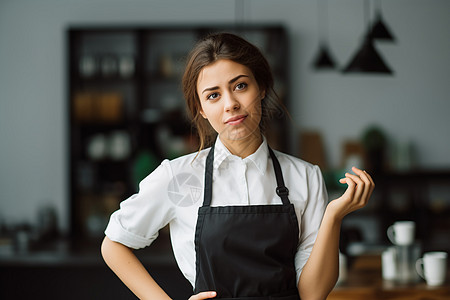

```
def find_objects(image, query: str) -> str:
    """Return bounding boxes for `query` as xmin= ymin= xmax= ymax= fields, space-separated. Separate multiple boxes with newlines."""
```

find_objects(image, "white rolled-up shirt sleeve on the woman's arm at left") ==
xmin=105 ymin=160 xmax=174 ymax=249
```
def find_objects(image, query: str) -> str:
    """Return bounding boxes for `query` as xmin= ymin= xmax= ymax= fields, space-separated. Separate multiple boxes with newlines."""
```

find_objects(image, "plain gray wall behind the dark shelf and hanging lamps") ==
xmin=0 ymin=0 xmax=450 ymax=229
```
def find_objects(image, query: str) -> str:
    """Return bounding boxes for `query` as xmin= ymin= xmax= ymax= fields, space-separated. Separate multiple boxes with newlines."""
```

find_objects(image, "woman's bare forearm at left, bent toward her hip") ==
xmin=101 ymin=237 xmax=170 ymax=300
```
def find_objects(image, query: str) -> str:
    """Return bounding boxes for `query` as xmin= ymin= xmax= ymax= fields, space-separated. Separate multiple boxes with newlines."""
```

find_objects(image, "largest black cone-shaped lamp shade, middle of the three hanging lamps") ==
xmin=342 ymin=35 xmax=393 ymax=74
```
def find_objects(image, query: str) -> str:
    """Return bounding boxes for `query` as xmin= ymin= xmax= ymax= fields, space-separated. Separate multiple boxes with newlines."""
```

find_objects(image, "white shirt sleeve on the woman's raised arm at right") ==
xmin=295 ymin=166 xmax=328 ymax=282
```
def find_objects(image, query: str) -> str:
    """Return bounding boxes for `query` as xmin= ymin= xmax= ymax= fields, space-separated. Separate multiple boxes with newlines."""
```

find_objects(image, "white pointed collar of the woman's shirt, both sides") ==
xmin=214 ymin=136 xmax=269 ymax=175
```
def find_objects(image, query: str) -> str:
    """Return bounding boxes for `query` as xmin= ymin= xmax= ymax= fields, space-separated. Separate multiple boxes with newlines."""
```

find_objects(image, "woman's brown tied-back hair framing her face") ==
xmin=182 ymin=33 xmax=280 ymax=150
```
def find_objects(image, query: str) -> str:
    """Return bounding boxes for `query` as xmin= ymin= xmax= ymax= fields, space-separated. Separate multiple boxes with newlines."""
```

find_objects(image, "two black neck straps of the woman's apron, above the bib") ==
xmin=203 ymin=145 xmax=290 ymax=206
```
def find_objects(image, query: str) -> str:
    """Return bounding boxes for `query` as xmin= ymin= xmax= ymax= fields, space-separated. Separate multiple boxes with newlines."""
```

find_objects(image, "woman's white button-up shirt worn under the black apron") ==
xmin=105 ymin=138 xmax=327 ymax=286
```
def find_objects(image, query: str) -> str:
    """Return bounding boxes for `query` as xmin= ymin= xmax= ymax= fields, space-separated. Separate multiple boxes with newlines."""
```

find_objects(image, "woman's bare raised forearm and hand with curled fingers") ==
xmin=298 ymin=168 xmax=375 ymax=300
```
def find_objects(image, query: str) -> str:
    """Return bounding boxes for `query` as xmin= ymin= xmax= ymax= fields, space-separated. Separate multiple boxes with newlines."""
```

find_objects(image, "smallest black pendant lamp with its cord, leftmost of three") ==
xmin=313 ymin=0 xmax=336 ymax=70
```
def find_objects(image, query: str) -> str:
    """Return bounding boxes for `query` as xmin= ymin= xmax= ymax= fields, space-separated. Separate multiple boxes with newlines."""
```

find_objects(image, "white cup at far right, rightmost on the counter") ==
xmin=416 ymin=252 xmax=447 ymax=286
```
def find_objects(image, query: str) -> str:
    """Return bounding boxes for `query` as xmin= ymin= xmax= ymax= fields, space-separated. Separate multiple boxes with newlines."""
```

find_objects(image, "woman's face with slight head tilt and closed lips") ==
xmin=197 ymin=59 xmax=265 ymax=142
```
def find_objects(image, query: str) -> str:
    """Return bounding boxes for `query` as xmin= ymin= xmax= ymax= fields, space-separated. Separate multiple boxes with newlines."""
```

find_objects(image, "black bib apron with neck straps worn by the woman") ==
xmin=194 ymin=145 xmax=300 ymax=300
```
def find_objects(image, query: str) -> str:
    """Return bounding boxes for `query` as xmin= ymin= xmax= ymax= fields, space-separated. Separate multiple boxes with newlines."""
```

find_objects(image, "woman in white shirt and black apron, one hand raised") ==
xmin=102 ymin=33 xmax=374 ymax=300
